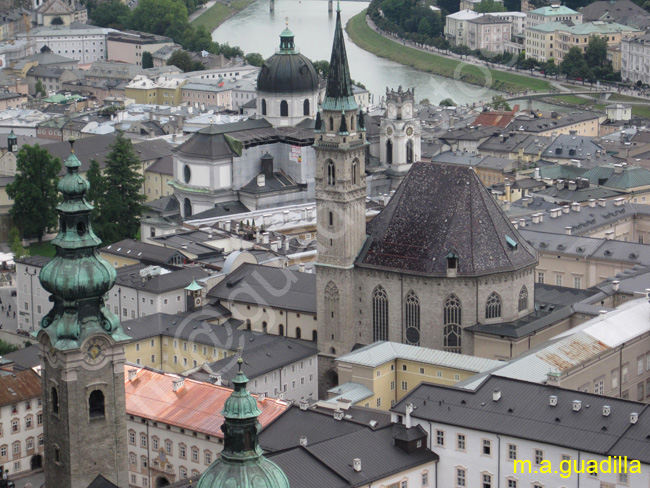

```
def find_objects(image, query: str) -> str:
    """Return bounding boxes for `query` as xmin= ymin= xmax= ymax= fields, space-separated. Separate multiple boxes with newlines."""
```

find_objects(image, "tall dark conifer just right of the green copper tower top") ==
xmin=95 ymin=132 xmax=146 ymax=243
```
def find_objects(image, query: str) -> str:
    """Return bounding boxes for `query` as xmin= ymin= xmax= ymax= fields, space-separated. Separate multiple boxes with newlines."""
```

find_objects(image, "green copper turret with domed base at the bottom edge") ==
xmin=196 ymin=358 xmax=289 ymax=488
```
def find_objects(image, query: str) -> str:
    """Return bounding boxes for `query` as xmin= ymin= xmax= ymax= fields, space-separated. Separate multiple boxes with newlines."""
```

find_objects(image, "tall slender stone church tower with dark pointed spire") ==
xmin=314 ymin=0 xmax=367 ymax=384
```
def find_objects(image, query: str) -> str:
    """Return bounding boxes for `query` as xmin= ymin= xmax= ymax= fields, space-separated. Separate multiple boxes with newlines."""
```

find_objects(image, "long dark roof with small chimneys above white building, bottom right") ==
xmin=391 ymin=376 xmax=650 ymax=463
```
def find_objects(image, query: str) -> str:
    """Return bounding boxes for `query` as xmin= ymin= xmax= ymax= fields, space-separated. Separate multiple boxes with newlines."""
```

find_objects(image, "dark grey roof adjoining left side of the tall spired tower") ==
xmin=208 ymin=263 xmax=316 ymax=314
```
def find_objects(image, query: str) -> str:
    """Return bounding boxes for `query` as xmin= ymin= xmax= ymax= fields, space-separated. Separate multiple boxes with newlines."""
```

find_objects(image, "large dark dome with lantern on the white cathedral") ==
xmin=257 ymin=21 xmax=318 ymax=94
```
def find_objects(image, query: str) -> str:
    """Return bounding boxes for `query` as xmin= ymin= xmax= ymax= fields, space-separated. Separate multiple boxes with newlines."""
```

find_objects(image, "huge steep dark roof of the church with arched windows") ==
xmin=356 ymin=163 xmax=537 ymax=276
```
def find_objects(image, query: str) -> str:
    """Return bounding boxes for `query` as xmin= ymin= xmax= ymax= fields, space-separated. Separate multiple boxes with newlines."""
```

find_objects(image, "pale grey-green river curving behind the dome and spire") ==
xmin=212 ymin=0 xmax=497 ymax=104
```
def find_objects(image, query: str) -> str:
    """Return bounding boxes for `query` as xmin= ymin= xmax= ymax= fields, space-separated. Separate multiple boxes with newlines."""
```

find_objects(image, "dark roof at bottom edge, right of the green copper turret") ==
xmin=267 ymin=426 xmax=438 ymax=488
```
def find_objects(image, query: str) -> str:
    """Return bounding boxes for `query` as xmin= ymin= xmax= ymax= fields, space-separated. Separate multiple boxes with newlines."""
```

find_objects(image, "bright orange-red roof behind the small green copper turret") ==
xmin=124 ymin=365 xmax=289 ymax=438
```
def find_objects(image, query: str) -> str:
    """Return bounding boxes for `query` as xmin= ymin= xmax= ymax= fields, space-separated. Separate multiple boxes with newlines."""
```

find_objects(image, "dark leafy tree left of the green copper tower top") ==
xmin=7 ymin=144 xmax=61 ymax=244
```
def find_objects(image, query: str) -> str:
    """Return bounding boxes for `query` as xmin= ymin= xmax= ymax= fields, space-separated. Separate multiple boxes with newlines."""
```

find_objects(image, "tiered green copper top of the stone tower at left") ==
xmin=39 ymin=141 xmax=129 ymax=350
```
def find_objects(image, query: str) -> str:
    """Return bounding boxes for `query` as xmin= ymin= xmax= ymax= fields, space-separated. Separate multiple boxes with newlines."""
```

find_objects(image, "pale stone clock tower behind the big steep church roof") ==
xmin=379 ymin=86 xmax=422 ymax=178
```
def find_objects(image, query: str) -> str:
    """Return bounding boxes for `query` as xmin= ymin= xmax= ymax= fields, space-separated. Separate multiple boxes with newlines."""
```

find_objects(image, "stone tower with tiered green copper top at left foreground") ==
xmin=37 ymin=141 xmax=129 ymax=488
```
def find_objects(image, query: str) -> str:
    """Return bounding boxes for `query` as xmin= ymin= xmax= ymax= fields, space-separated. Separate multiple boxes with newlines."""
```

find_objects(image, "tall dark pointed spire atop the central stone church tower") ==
xmin=323 ymin=3 xmax=357 ymax=110
